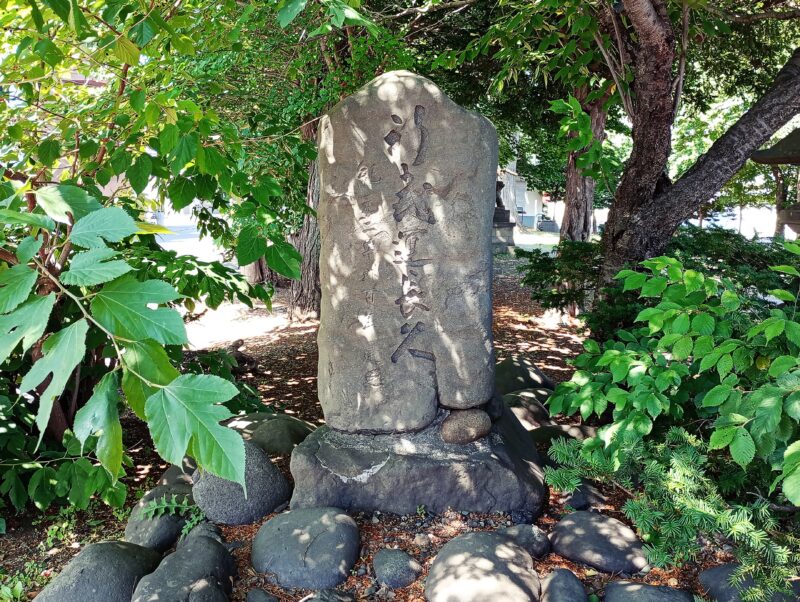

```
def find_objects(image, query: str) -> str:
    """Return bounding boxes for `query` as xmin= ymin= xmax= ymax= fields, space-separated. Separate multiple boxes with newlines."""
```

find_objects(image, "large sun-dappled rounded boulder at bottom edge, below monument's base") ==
xmin=425 ymin=531 xmax=540 ymax=602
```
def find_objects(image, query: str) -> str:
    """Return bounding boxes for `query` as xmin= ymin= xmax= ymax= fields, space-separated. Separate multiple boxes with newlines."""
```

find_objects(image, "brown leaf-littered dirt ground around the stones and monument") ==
xmin=0 ymin=253 xmax=722 ymax=602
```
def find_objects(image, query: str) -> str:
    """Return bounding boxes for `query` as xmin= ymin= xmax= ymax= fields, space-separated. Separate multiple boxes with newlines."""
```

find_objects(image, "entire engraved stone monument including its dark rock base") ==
xmin=291 ymin=71 xmax=545 ymax=513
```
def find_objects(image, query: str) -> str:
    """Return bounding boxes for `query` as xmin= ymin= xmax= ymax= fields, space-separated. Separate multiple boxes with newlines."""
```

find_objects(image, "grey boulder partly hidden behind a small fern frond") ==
xmin=125 ymin=483 xmax=192 ymax=552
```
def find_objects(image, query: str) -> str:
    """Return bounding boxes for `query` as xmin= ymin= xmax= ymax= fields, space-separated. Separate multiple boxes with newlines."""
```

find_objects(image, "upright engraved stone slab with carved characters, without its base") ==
xmin=318 ymin=71 xmax=496 ymax=432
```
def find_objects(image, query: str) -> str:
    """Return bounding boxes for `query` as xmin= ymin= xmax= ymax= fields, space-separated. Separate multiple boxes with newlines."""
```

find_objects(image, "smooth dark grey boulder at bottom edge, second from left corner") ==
xmin=131 ymin=537 xmax=236 ymax=602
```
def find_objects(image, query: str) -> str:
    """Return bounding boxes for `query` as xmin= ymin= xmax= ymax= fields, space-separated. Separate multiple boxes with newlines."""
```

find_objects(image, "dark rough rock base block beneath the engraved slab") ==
xmin=291 ymin=409 xmax=547 ymax=516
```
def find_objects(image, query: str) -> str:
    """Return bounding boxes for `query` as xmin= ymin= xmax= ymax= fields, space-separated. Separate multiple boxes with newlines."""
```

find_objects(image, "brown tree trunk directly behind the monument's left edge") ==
xmin=289 ymin=161 xmax=321 ymax=321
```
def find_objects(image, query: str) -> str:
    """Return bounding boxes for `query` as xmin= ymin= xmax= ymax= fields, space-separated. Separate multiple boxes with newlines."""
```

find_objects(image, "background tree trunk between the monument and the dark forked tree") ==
xmin=561 ymin=87 xmax=608 ymax=241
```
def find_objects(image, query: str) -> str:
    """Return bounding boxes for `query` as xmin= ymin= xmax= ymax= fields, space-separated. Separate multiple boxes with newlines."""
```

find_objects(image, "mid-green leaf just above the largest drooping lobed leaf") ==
xmin=122 ymin=341 xmax=180 ymax=420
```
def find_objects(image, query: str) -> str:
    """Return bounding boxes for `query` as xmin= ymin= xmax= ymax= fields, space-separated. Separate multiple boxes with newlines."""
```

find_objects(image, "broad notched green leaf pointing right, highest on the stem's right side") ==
xmin=92 ymin=276 xmax=187 ymax=345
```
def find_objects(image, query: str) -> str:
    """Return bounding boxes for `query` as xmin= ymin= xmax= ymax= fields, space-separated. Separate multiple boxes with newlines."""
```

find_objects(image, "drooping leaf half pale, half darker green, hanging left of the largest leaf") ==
xmin=73 ymin=372 xmax=122 ymax=481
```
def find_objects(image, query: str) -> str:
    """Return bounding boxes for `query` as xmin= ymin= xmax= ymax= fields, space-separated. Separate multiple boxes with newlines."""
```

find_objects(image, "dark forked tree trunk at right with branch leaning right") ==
xmin=601 ymin=41 xmax=800 ymax=285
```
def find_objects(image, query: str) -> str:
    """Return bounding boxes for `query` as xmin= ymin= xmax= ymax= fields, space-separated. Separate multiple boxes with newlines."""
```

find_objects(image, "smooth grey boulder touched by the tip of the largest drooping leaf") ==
xmin=193 ymin=441 xmax=291 ymax=525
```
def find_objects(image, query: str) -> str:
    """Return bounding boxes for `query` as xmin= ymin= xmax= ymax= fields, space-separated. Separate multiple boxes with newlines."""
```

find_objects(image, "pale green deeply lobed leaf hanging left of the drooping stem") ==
xmin=19 ymin=319 xmax=89 ymax=446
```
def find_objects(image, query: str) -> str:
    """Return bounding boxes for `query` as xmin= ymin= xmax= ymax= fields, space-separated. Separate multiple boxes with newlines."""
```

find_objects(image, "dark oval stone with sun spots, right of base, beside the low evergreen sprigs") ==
xmin=550 ymin=511 xmax=647 ymax=574
